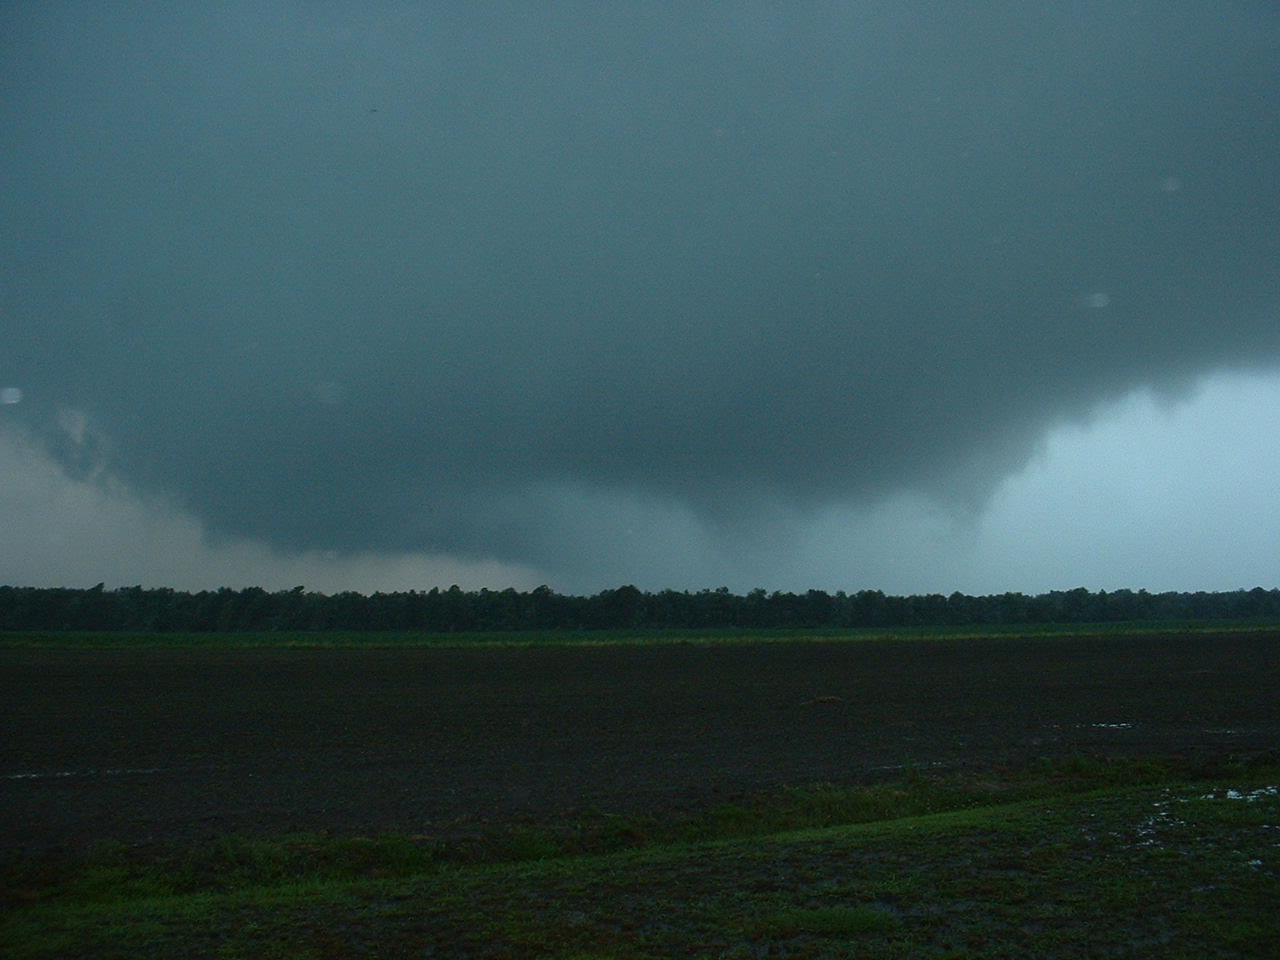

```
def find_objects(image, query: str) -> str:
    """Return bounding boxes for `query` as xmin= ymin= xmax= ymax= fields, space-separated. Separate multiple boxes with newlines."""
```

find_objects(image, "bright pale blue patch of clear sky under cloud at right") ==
xmin=974 ymin=374 xmax=1280 ymax=593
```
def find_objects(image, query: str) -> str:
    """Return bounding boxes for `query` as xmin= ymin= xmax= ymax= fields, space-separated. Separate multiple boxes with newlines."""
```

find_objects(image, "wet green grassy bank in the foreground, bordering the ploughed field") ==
xmin=0 ymin=756 xmax=1280 ymax=960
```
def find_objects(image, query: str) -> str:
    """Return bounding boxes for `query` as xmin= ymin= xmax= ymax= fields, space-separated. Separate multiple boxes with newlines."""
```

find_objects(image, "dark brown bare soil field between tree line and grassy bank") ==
xmin=0 ymin=632 xmax=1280 ymax=851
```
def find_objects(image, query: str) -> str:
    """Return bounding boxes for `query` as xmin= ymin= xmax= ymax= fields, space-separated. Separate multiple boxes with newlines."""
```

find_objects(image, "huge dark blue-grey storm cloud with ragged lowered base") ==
xmin=0 ymin=0 xmax=1280 ymax=586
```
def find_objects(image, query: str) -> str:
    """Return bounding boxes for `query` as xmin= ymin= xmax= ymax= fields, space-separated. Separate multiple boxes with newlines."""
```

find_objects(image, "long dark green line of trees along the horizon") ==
xmin=0 ymin=584 xmax=1280 ymax=634
